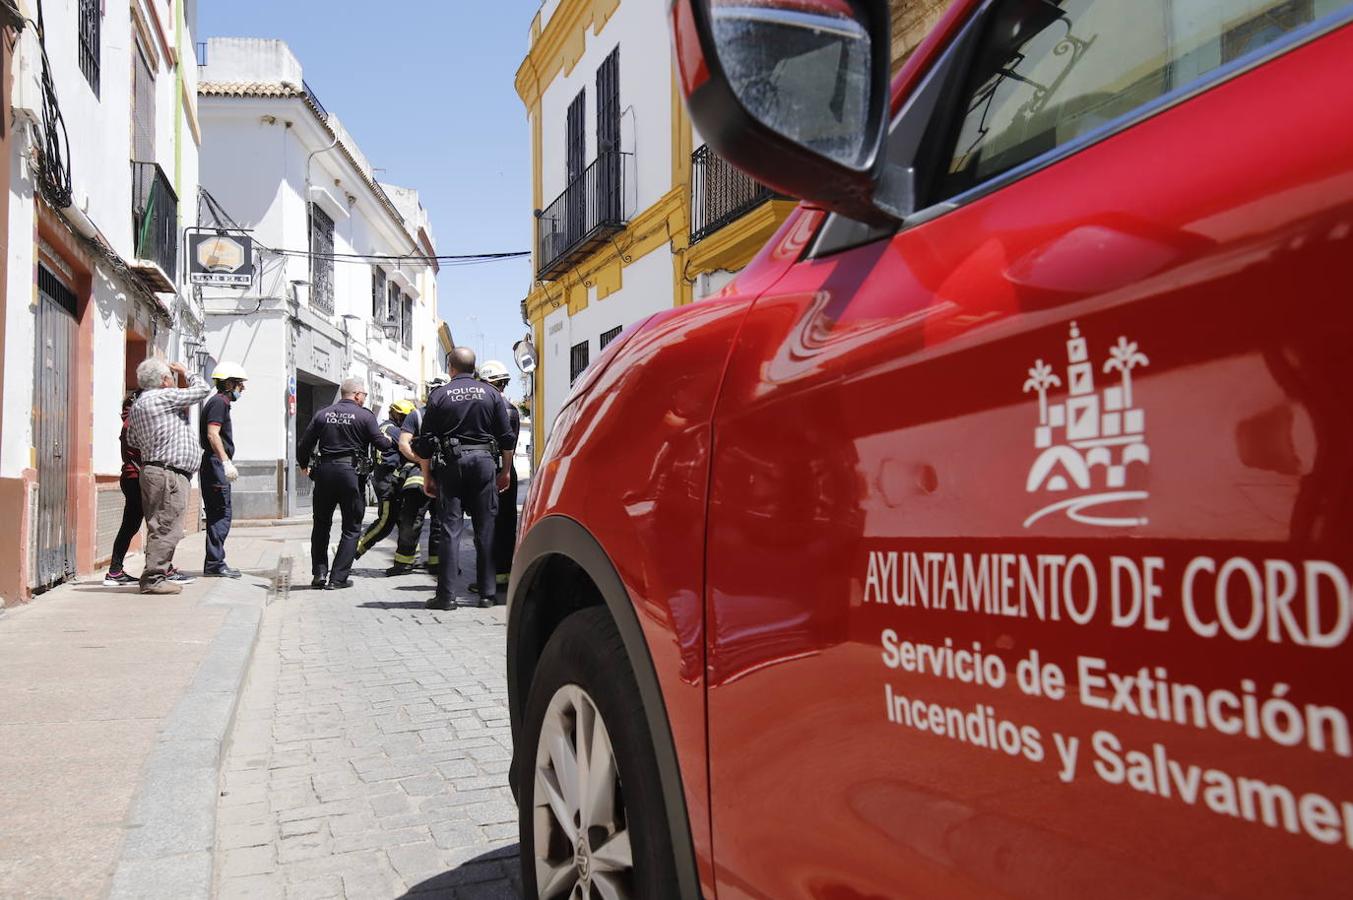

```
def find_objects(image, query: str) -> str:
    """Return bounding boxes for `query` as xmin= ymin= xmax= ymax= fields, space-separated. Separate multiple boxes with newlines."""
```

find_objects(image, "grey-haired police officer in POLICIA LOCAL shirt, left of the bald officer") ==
xmin=296 ymin=378 xmax=394 ymax=590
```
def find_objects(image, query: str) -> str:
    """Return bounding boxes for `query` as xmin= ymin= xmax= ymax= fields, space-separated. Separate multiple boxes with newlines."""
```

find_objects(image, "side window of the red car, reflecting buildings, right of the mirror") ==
xmin=934 ymin=0 xmax=1353 ymax=200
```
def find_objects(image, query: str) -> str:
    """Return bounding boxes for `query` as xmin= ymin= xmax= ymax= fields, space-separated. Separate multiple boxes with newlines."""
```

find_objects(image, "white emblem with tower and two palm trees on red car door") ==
xmin=1024 ymin=322 xmax=1151 ymax=528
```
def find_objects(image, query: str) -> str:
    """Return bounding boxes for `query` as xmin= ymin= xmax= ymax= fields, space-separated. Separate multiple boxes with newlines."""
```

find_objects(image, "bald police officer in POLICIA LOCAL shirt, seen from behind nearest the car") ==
xmin=414 ymin=346 xmax=517 ymax=609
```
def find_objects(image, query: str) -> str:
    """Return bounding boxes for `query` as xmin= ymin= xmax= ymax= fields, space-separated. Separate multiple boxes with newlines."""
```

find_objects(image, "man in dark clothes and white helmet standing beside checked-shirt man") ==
xmin=198 ymin=363 xmax=249 ymax=578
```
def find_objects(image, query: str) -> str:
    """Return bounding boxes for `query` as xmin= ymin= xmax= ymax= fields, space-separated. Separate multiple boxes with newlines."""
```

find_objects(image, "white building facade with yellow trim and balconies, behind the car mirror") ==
xmin=515 ymin=0 xmax=950 ymax=457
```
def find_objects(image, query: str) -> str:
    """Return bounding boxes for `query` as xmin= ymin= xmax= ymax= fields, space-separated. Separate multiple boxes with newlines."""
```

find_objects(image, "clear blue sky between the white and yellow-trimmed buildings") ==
xmin=196 ymin=0 xmax=540 ymax=394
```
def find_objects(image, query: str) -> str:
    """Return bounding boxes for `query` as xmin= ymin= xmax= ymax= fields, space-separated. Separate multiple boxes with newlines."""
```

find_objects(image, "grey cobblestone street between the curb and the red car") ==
xmin=216 ymin=528 xmax=520 ymax=900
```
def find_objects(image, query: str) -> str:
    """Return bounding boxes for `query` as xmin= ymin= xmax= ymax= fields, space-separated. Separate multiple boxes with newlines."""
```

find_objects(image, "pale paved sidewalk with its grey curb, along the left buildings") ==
xmin=0 ymin=525 xmax=293 ymax=899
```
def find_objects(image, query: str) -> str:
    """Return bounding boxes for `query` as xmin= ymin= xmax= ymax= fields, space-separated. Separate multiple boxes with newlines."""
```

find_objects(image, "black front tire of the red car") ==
xmin=518 ymin=606 xmax=679 ymax=899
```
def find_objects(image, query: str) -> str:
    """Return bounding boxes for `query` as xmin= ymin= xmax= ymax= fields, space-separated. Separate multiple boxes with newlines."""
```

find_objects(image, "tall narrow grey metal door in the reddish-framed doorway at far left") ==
xmin=31 ymin=265 xmax=76 ymax=590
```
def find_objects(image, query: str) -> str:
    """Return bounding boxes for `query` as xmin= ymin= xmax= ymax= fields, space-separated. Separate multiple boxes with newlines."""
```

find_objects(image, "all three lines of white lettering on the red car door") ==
xmin=863 ymin=551 xmax=1353 ymax=849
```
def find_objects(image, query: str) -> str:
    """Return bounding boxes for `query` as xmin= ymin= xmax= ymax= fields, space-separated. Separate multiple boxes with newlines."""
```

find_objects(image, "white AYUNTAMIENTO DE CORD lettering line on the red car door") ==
xmin=865 ymin=551 xmax=1353 ymax=647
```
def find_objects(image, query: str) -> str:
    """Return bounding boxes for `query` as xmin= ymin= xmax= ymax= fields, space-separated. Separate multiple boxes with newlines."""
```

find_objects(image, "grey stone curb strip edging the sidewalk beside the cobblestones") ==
xmin=108 ymin=571 xmax=274 ymax=900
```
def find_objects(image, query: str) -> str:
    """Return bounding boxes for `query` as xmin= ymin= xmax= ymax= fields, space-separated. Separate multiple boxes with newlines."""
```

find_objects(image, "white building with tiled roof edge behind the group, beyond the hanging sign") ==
xmin=199 ymin=38 xmax=441 ymax=518
